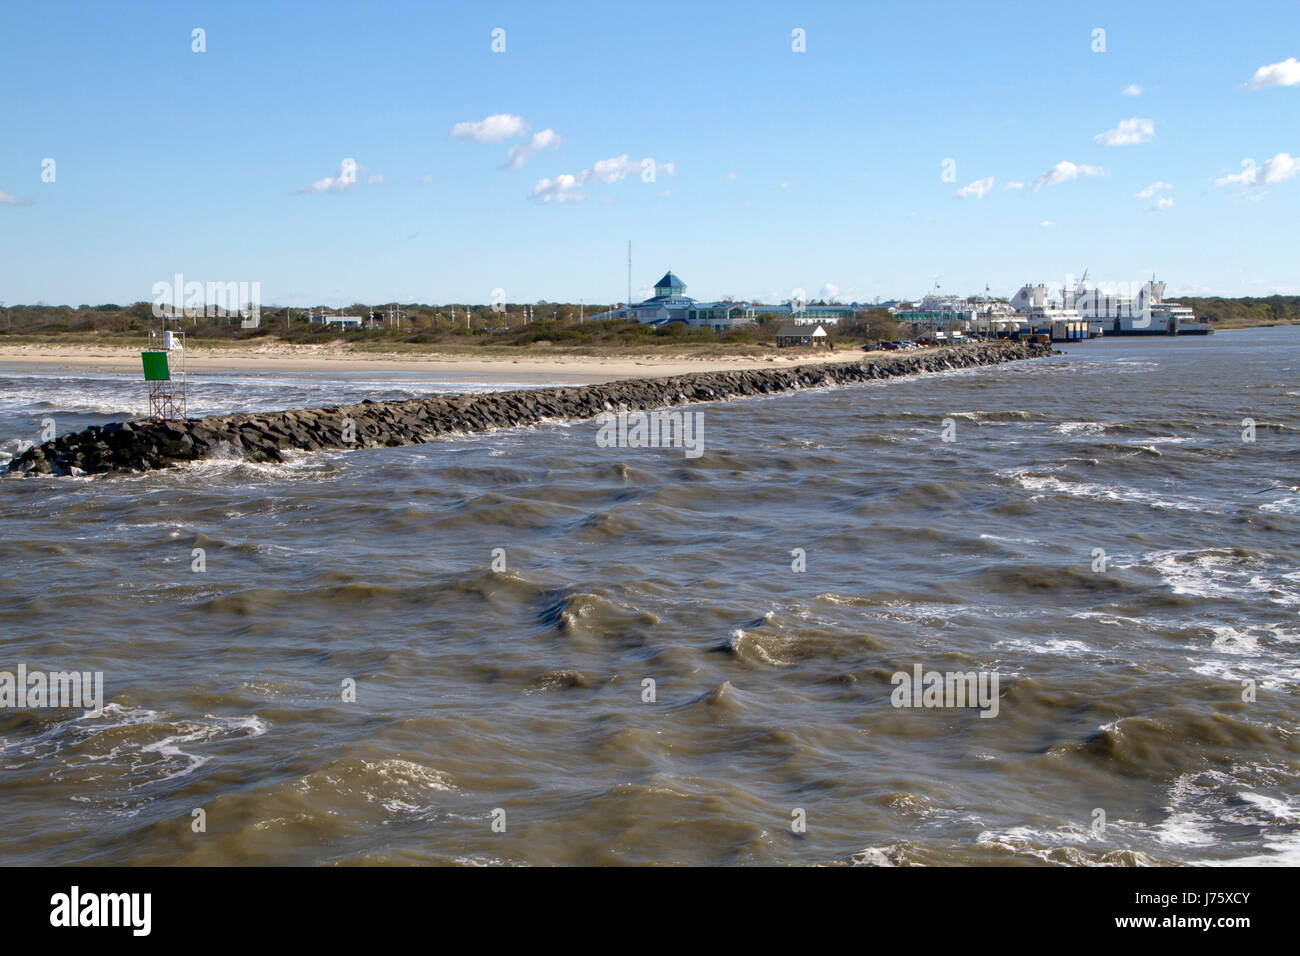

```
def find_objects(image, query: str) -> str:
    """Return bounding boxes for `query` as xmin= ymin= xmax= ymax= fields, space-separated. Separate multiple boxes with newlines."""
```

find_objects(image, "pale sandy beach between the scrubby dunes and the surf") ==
xmin=0 ymin=343 xmax=866 ymax=385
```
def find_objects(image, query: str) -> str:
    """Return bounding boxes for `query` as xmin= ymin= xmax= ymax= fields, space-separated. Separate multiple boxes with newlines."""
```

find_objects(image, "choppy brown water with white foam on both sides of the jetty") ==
xmin=0 ymin=329 xmax=1300 ymax=864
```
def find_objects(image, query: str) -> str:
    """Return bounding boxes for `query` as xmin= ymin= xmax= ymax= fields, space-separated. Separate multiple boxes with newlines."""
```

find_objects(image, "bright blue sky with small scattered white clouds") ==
xmin=0 ymin=0 xmax=1300 ymax=306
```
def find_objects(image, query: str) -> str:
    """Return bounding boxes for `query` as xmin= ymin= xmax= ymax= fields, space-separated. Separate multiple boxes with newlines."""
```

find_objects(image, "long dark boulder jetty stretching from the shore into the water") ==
xmin=8 ymin=342 xmax=1053 ymax=475
